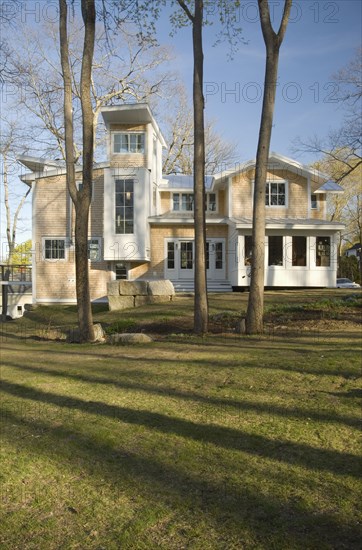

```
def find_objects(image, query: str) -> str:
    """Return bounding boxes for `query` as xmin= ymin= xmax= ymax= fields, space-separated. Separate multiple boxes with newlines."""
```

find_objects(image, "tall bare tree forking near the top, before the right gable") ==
xmin=246 ymin=0 xmax=292 ymax=334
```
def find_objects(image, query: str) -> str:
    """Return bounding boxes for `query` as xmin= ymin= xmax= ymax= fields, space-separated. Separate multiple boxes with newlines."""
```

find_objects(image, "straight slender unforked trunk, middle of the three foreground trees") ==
xmin=192 ymin=0 xmax=208 ymax=334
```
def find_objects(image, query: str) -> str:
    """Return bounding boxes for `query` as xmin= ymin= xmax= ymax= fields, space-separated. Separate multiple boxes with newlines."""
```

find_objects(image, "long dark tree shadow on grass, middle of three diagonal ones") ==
xmin=0 ymin=380 xmax=361 ymax=478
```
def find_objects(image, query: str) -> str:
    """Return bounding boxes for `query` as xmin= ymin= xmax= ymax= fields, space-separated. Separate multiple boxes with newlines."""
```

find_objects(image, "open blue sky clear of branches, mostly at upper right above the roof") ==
xmin=0 ymin=0 xmax=362 ymax=254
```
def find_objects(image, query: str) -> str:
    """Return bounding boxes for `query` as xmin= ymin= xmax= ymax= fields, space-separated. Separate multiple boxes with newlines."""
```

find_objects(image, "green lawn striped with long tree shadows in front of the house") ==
xmin=0 ymin=291 xmax=362 ymax=550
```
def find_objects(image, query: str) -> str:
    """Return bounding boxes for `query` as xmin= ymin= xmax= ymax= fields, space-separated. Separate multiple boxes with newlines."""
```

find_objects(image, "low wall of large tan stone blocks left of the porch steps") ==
xmin=107 ymin=279 xmax=175 ymax=311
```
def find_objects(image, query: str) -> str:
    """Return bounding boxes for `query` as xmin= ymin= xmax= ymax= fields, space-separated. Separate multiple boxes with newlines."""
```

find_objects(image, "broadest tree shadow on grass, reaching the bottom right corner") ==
xmin=4 ymin=408 xmax=361 ymax=550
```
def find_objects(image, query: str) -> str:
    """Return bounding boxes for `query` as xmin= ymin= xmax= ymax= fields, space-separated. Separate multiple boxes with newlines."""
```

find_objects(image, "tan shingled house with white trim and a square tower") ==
xmin=19 ymin=104 xmax=343 ymax=303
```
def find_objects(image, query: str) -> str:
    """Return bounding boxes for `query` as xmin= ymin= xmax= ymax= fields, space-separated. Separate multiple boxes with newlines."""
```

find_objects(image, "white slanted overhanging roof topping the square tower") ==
xmin=101 ymin=103 xmax=166 ymax=147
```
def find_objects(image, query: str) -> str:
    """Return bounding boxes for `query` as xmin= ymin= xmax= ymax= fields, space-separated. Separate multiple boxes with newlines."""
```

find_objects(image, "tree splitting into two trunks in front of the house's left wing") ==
xmin=59 ymin=0 xmax=96 ymax=342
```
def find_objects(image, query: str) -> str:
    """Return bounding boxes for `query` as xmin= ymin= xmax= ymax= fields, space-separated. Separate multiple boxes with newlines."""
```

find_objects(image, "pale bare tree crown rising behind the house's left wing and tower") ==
xmin=4 ymin=17 xmax=170 ymax=161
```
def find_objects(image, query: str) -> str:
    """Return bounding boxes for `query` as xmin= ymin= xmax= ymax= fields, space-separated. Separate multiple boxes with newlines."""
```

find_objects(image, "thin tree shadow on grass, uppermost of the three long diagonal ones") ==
xmin=3 ymin=363 xmax=362 ymax=434
